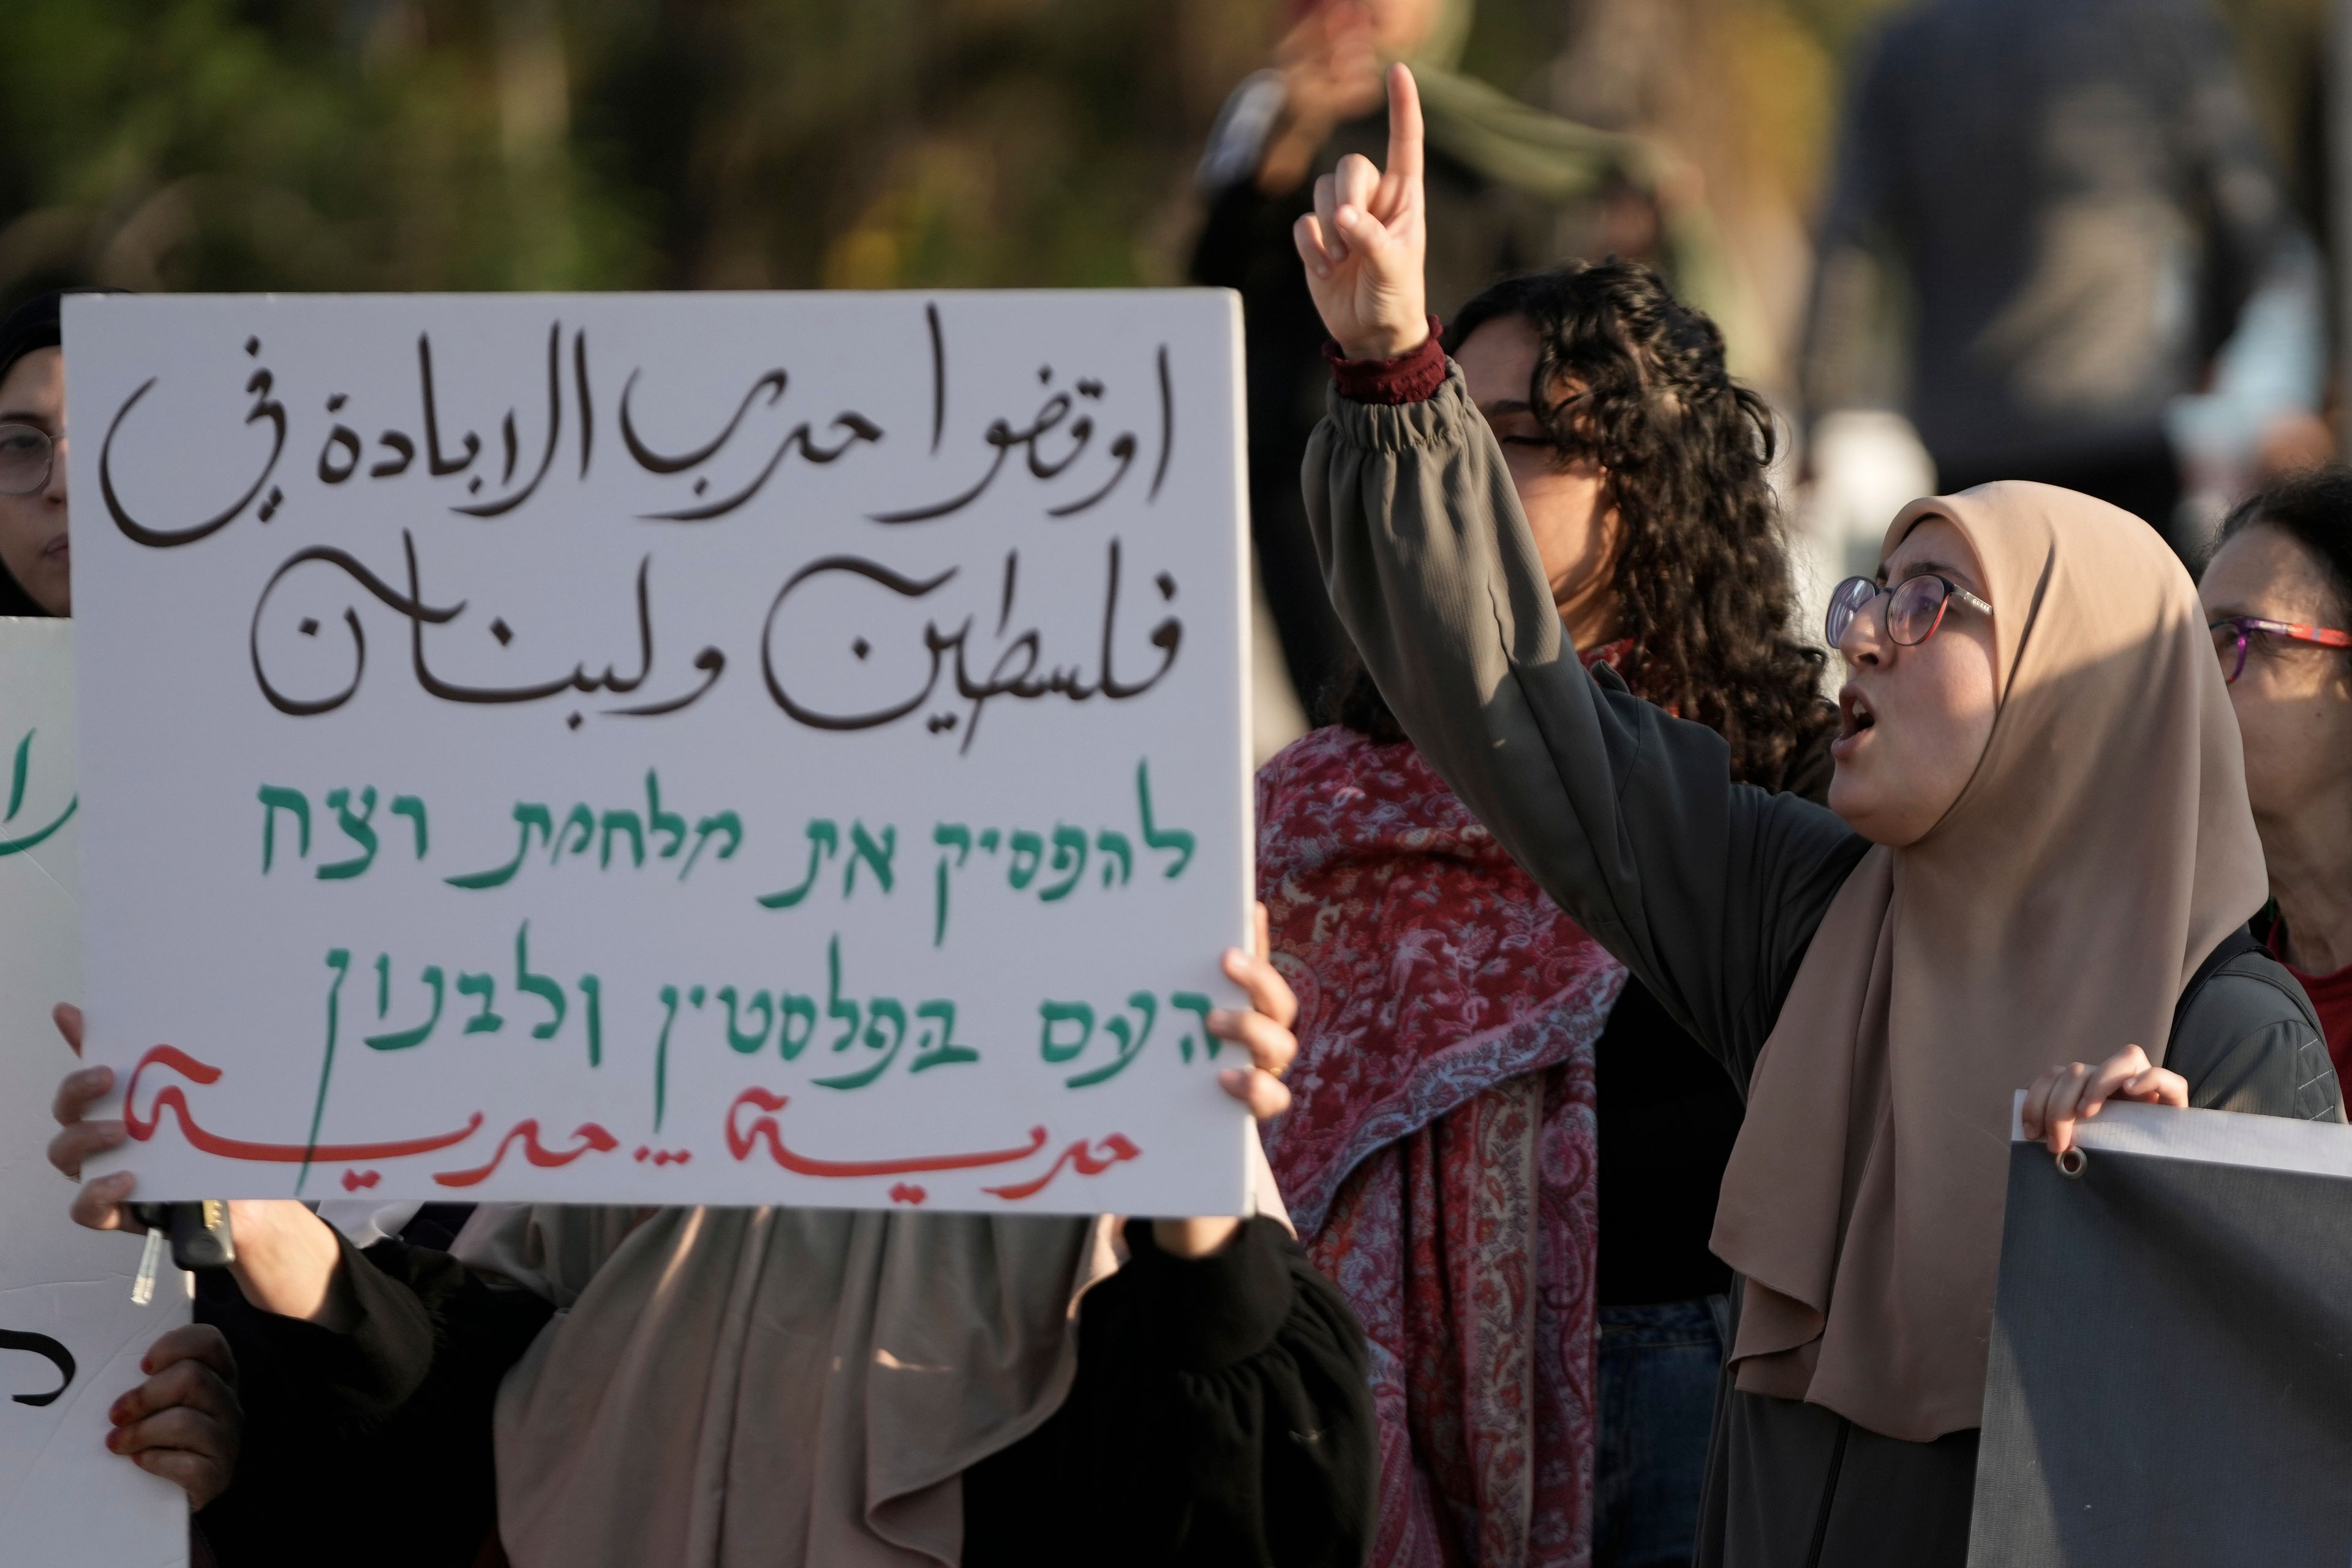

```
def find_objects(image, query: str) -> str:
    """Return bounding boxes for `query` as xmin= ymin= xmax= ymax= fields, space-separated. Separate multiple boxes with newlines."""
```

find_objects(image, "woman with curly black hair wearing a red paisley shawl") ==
xmin=1258 ymin=261 xmax=1837 ymax=1568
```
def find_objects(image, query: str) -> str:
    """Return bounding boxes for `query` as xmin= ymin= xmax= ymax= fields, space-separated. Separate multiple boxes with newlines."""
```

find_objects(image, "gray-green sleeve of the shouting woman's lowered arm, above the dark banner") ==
xmin=2164 ymin=954 xmax=2345 ymax=1121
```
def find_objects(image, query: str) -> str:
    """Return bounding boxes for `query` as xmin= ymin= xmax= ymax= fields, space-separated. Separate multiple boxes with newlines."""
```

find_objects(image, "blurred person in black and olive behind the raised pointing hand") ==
xmin=1190 ymin=0 xmax=1698 ymax=719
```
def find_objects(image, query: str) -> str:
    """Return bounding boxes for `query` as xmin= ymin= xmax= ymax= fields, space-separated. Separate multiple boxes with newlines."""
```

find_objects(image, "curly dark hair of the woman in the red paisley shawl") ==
xmin=1336 ymin=256 xmax=1837 ymax=788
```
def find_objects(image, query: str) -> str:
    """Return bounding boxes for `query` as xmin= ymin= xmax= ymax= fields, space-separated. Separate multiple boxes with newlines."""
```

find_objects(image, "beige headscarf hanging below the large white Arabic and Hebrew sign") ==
xmin=456 ymin=1206 xmax=1117 ymax=1568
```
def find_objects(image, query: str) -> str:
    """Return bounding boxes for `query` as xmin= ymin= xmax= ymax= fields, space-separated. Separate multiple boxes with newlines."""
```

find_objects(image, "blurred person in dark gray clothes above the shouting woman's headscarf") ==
xmin=1801 ymin=0 xmax=2321 ymax=545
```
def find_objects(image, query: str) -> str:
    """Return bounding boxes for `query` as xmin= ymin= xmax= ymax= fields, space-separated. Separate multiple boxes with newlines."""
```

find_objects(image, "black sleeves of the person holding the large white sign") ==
xmin=200 ymin=1218 xmax=1378 ymax=1568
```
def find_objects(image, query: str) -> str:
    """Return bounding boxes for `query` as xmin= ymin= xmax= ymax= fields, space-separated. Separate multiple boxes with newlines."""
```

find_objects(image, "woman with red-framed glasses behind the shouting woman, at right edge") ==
xmin=2197 ymin=468 xmax=2352 ymax=1079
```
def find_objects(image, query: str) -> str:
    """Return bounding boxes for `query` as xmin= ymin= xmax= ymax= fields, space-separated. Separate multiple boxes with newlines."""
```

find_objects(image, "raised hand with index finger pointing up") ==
xmin=1291 ymin=64 xmax=1430 ymax=360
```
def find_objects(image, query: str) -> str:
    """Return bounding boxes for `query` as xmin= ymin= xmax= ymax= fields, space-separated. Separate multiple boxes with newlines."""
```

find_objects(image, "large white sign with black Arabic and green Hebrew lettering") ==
xmin=66 ymin=292 xmax=1254 ymax=1213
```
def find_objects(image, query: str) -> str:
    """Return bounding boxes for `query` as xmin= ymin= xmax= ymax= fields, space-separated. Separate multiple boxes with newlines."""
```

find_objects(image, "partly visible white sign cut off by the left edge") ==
xmin=0 ymin=618 xmax=188 ymax=1568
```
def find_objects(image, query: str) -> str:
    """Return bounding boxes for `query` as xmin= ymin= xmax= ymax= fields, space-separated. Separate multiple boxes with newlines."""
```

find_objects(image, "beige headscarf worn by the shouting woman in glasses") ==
xmin=1713 ymin=482 xmax=2265 ymax=1441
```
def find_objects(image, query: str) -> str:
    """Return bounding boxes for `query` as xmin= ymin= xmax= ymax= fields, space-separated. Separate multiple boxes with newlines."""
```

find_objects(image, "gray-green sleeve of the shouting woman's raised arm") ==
xmin=1303 ymin=367 xmax=1865 ymax=1082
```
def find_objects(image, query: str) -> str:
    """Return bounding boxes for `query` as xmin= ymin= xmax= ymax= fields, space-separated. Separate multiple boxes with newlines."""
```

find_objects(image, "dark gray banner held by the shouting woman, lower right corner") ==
xmin=1969 ymin=1107 xmax=2352 ymax=1568
